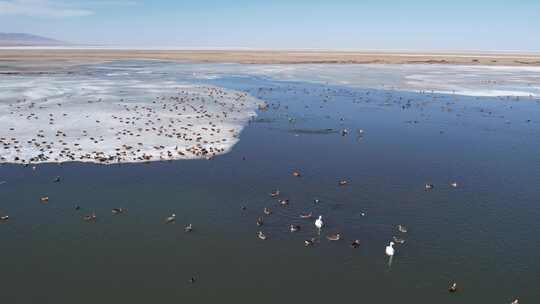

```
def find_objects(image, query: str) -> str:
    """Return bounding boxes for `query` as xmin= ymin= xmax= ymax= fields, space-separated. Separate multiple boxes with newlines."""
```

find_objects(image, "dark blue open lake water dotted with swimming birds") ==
xmin=0 ymin=62 xmax=540 ymax=303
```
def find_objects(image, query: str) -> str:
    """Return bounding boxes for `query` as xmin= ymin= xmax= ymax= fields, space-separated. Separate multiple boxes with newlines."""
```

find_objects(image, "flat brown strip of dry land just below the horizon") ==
xmin=0 ymin=49 xmax=540 ymax=73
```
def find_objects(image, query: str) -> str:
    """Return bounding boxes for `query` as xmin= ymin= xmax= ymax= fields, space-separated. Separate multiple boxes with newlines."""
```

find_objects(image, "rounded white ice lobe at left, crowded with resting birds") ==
xmin=0 ymin=73 xmax=259 ymax=164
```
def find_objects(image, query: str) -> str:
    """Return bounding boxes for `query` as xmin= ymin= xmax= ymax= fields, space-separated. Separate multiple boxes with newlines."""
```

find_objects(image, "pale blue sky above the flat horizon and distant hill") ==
xmin=0 ymin=0 xmax=540 ymax=52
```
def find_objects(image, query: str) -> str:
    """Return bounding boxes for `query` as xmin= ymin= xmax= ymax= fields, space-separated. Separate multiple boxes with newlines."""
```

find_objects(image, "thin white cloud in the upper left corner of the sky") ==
xmin=0 ymin=0 xmax=94 ymax=18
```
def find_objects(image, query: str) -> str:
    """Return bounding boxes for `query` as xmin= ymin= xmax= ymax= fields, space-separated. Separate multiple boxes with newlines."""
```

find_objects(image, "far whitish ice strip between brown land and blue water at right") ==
xmin=182 ymin=64 xmax=540 ymax=98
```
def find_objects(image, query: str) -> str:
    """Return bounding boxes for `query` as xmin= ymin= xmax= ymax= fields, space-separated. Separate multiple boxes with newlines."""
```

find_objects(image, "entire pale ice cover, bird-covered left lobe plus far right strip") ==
xmin=0 ymin=61 xmax=540 ymax=164
